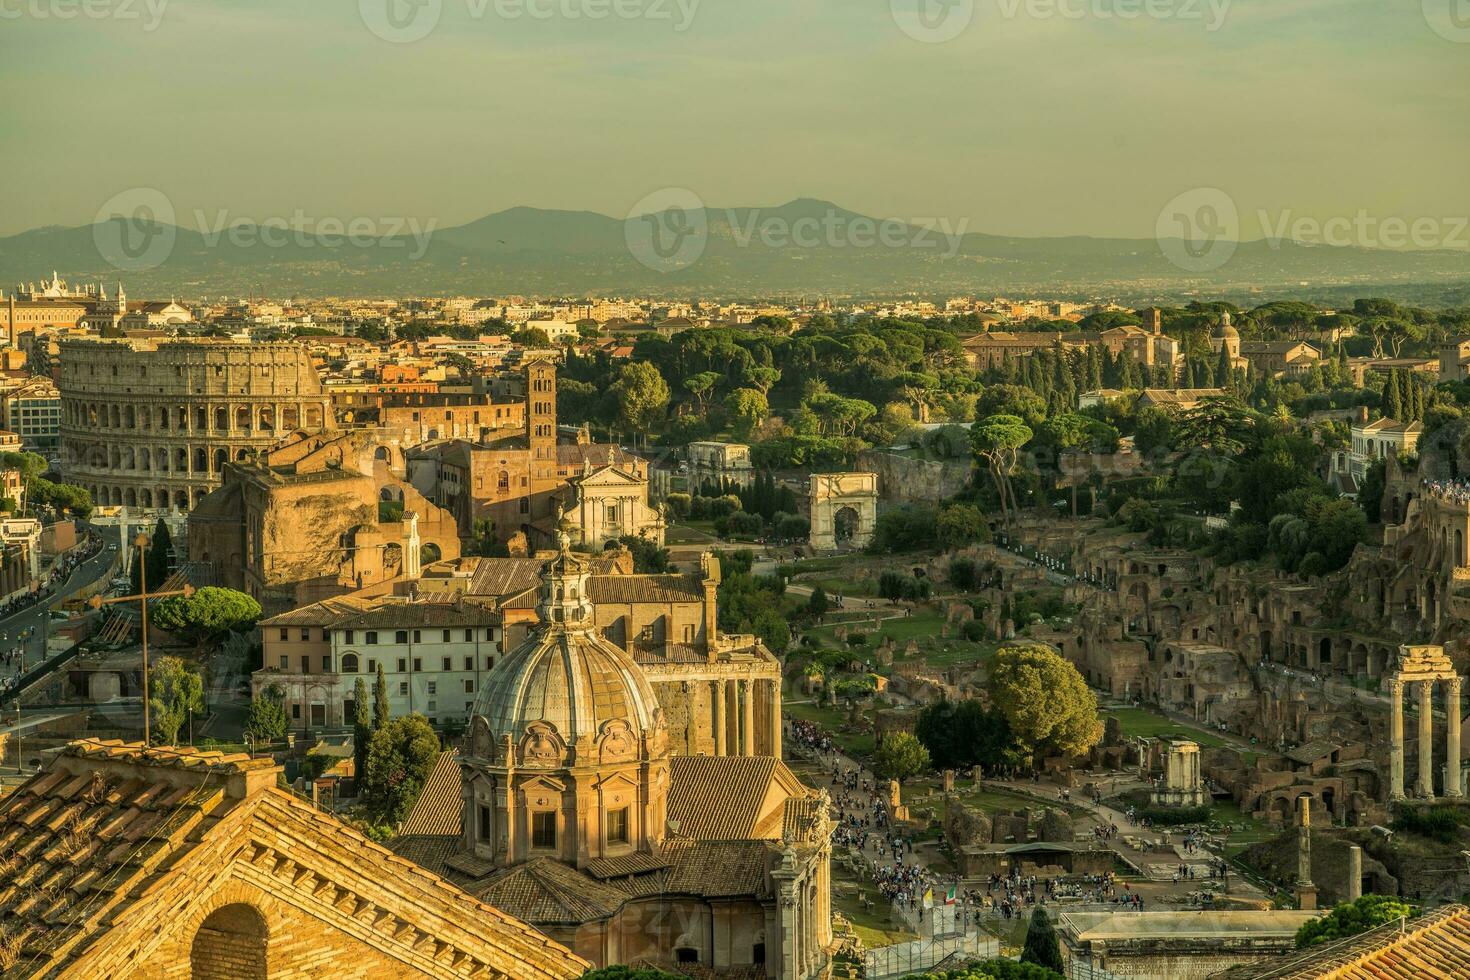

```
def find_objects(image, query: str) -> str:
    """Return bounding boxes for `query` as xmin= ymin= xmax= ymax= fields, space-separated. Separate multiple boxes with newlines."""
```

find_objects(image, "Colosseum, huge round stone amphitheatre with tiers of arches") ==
xmin=57 ymin=338 xmax=335 ymax=510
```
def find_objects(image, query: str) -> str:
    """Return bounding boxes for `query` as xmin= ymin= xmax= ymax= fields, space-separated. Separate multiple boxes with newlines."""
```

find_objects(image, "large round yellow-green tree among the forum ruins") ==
xmin=991 ymin=644 xmax=1103 ymax=757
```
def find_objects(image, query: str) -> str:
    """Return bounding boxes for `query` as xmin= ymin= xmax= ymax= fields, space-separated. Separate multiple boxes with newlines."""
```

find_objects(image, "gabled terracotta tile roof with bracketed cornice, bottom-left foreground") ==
xmin=0 ymin=739 xmax=588 ymax=980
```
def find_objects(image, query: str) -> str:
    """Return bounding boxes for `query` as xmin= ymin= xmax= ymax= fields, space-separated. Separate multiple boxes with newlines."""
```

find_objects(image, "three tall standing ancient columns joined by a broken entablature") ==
xmin=1389 ymin=646 xmax=1464 ymax=799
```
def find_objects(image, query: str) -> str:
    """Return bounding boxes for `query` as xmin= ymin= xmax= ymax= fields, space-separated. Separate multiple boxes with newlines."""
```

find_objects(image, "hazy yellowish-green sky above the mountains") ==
xmin=0 ymin=0 xmax=1470 ymax=238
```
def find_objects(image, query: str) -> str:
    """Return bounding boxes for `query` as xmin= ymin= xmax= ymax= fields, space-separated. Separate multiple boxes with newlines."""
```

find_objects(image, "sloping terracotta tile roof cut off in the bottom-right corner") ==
xmin=1247 ymin=905 xmax=1470 ymax=980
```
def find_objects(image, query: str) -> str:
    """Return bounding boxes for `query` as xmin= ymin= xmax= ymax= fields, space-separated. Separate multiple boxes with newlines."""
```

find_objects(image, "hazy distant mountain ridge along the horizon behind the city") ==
xmin=0 ymin=198 xmax=1470 ymax=304
